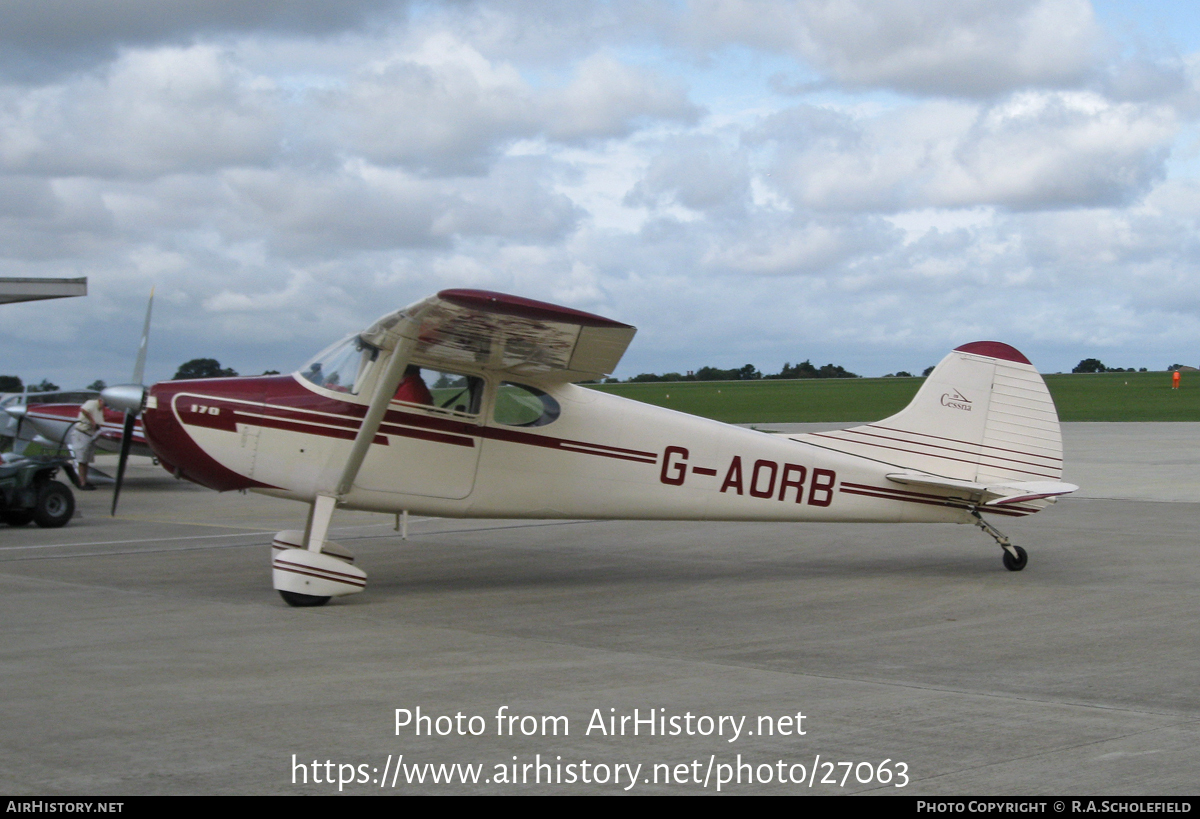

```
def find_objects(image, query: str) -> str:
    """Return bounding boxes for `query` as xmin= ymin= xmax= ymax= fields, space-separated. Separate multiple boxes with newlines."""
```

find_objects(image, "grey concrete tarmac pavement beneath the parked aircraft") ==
xmin=0 ymin=424 xmax=1200 ymax=795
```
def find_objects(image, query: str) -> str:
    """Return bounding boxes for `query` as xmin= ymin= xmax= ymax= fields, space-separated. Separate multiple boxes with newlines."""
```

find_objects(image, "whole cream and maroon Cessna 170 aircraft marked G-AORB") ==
xmin=103 ymin=289 xmax=1078 ymax=606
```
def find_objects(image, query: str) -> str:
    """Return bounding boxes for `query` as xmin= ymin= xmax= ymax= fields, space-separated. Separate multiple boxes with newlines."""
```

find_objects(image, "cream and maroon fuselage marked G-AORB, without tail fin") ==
xmin=136 ymin=372 xmax=1017 ymax=522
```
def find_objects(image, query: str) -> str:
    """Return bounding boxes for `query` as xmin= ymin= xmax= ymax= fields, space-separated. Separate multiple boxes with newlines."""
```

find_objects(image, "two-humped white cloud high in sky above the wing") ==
xmin=323 ymin=32 xmax=700 ymax=175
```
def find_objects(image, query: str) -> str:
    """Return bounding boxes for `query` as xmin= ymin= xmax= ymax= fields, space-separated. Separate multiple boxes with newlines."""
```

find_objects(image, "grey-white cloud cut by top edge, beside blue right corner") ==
xmin=685 ymin=0 xmax=1099 ymax=96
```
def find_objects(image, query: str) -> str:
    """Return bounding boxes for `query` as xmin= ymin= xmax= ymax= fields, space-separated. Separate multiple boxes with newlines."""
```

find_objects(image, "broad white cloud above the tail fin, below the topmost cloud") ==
xmin=754 ymin=91 xmax=1180 ymax=211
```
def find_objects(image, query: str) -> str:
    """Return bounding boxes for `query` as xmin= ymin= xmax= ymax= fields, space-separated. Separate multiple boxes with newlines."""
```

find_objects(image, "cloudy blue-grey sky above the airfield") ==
xmin=0 ymin=0 xmax=1200 ymax=387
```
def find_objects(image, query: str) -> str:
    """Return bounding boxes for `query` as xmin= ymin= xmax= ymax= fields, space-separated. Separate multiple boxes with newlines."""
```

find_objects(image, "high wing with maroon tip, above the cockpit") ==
xmin=361 ymin=289 xmax=637 ymax=382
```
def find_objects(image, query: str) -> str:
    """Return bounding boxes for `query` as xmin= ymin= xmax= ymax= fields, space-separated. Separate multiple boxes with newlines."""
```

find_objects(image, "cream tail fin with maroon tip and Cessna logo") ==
xmin=805 ymin=341 xmax=1066 ymax=485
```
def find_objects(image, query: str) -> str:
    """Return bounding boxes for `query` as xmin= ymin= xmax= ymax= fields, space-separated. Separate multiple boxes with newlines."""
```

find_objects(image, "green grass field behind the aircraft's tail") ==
xmin=594 ymin=372 xmax=1200 ymax=424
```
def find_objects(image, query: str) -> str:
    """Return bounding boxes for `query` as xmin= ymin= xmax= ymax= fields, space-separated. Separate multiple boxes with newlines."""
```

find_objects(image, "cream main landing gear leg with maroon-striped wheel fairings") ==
xmin=271 ymin=495 xmax=367 ymax=608
